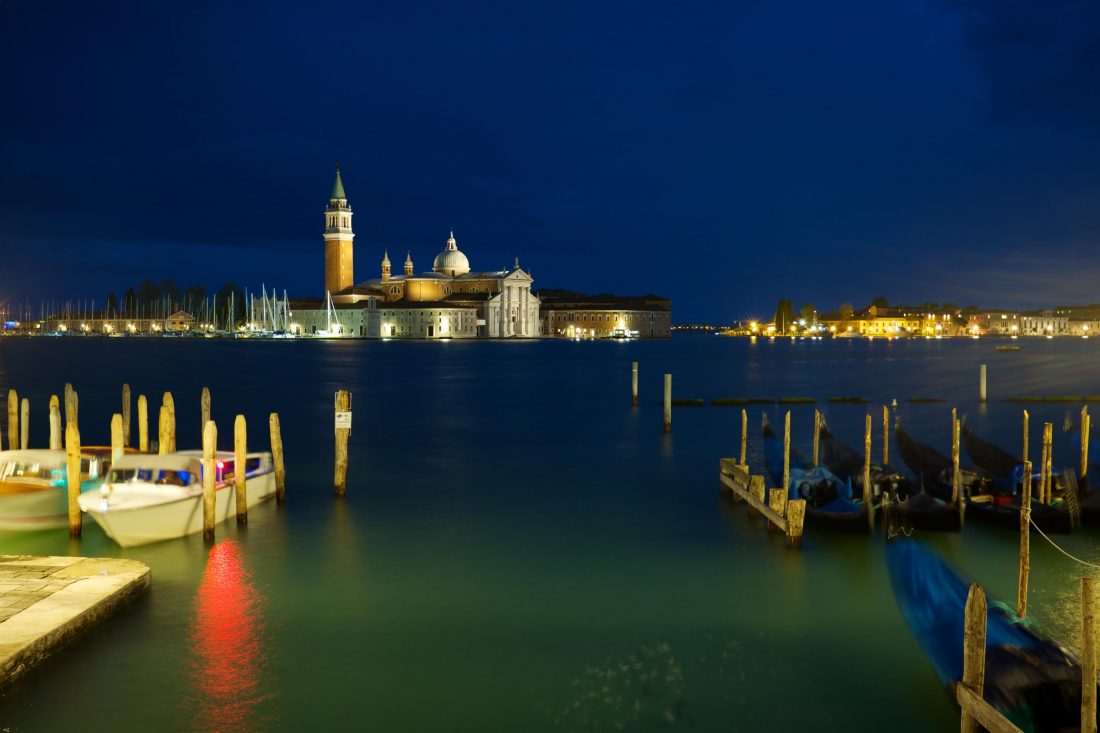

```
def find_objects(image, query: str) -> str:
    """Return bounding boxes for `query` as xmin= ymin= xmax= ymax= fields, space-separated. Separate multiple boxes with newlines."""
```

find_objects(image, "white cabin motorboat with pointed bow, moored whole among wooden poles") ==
xmin=79 ymin=450 xmax=275 ymax=547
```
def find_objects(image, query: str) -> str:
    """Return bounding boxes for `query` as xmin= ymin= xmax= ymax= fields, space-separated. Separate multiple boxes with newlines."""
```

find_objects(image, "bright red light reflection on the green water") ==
xmin=190 ymin=539 xmax=266 ymax=732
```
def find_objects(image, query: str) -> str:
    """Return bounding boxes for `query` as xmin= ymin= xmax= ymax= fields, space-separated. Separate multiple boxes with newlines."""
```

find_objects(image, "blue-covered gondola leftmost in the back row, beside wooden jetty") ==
xmin=763 ymin=418 xmax=871 ymax=534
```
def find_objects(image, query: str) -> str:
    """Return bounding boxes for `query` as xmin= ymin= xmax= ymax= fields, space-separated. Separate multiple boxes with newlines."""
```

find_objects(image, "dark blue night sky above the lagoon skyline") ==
xmin=0 ymin=0 xmax=1100 ymax=322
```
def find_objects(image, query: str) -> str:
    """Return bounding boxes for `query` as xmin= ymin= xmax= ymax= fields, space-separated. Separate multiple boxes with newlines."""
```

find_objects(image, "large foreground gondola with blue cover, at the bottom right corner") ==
xmin=887 ymin=537 xmax=1081 ymax=731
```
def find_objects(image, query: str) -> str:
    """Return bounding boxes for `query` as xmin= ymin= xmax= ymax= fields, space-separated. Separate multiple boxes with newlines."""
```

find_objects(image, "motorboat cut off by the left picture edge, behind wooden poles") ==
xmin=0 ymin=448 xmax=111 ymax=529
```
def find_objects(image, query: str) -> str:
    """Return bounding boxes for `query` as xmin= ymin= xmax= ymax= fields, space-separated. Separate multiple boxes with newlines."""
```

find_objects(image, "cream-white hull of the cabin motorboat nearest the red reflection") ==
xmin=85 ymin=472 xmax=275 ymax=547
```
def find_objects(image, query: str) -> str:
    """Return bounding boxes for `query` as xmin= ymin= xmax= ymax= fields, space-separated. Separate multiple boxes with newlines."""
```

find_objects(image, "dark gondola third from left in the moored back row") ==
xmin=894 ymin=420 xmax=1074 ymax=533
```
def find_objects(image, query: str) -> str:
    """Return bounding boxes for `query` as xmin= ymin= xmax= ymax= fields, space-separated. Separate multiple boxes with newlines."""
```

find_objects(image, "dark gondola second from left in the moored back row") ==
xmin=818 ymin=420 xmax=963 ymax=532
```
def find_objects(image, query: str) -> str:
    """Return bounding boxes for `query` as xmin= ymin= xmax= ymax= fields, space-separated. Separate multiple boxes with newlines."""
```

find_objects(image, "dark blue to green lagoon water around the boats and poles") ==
xmin=0 ymin=336 xmax=1100 ymax=731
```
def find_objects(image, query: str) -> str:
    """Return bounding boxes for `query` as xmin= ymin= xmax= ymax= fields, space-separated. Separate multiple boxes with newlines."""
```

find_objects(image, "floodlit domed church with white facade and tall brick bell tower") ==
xmin=287 ymin=165 xmax=540 ymax=339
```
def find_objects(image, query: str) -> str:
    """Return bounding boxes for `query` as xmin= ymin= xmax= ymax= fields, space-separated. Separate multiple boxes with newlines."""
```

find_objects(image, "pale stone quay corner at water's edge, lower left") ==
xmin=0 ymin=555 xmax=150 ymax=685
